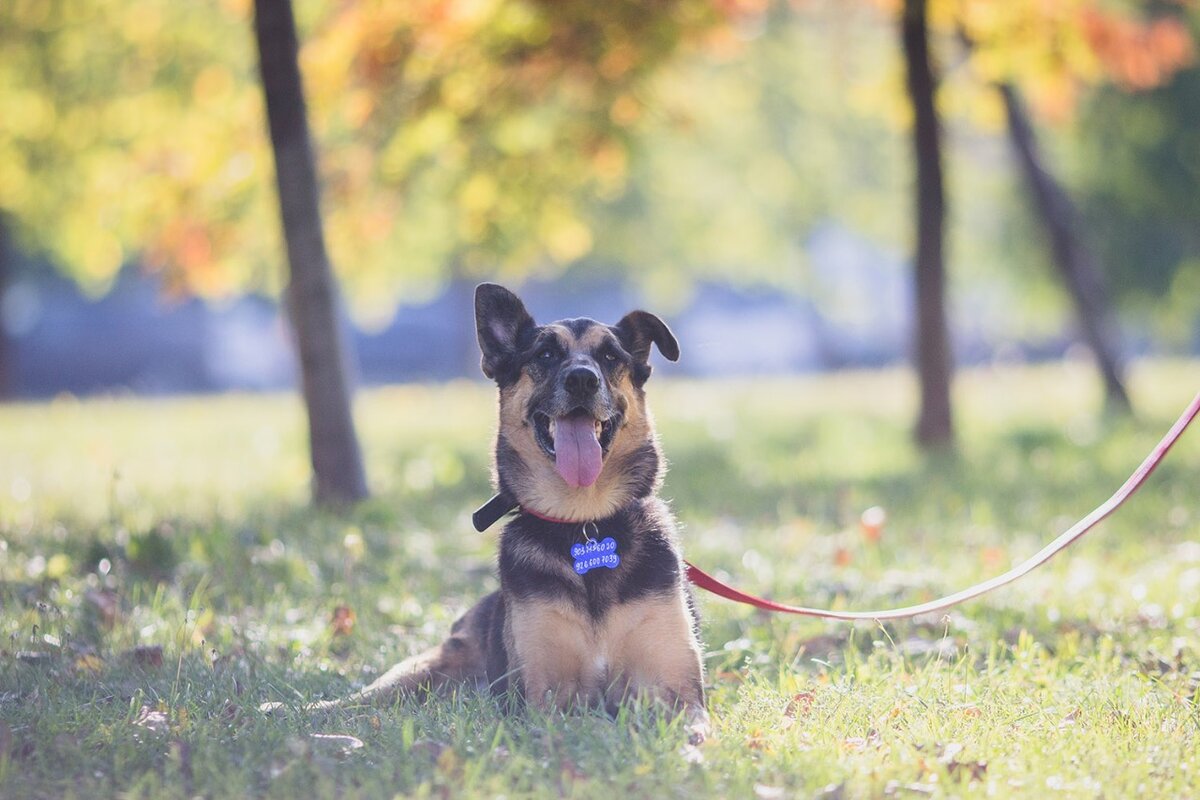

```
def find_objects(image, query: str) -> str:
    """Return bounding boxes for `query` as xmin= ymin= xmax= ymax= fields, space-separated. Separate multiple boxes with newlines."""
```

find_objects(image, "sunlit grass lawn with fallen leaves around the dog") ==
xmin=0 ymin=362 xmax=1200 ymax=799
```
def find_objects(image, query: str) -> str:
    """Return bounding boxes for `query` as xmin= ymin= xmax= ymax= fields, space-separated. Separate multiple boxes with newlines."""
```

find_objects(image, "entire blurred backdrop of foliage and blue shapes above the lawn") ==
xmin=0 ymin=0 xmax=1200 ymax=484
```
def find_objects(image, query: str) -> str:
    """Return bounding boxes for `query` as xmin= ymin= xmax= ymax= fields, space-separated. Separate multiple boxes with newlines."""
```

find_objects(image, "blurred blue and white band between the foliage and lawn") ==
xmin=0 ymin=224 xmax=1128 ymax=398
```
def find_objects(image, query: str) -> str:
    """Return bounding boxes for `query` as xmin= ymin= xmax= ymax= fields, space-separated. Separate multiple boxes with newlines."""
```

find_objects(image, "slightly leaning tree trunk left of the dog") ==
xmin=254 ymin=0 xmax=367 ymax=503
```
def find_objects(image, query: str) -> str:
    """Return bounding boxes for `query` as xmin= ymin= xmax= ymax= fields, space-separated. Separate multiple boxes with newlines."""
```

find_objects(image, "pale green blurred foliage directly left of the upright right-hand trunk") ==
xmin=589 ymin=2 xmax=908 ymax=296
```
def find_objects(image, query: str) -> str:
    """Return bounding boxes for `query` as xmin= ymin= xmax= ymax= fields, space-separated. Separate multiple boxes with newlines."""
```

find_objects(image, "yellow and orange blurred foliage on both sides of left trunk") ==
xmin=0 ymin=0 xmax=719 ymax=312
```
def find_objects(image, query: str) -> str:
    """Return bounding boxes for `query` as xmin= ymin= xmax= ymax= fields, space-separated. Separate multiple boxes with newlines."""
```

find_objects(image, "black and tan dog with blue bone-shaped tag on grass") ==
xmin=269 ymin=283 xmax=708 ymax=742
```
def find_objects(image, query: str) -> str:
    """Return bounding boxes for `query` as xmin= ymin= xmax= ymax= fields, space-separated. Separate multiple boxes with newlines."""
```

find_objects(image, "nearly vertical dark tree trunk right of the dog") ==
xmin=901 ymin=0 xmax=954 ymax=447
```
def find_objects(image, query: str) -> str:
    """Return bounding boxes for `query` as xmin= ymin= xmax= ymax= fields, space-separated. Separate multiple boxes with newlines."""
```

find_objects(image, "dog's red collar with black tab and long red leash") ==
xmin=492 ymin=395 xmax=1200 ymax=622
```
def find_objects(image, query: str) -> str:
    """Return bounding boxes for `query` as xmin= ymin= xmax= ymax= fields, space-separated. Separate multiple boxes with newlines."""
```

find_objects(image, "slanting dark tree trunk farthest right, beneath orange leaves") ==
xmin=998 ymin=84 xmax=1129 ymax=413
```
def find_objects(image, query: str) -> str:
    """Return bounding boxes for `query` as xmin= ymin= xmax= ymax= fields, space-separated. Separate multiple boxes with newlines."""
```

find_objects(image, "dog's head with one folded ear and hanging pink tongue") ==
xmin=475 ymin=283 xmax=679 ymax=521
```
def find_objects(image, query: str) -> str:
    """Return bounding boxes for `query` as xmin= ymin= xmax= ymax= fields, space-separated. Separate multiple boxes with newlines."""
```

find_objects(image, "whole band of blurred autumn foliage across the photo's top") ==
xmin=0 ymin=0 xmax=1200 ymax=337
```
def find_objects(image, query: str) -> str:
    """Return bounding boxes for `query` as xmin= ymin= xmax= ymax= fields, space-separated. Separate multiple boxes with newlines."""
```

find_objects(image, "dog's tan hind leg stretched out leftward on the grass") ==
xmin=259 ymin=593 xmax=499 ymax=714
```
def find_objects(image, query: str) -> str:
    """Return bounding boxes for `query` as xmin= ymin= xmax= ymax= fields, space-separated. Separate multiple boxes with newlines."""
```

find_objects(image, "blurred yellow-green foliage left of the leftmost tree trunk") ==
xmin=0 ymin=0 xmax=277 ymax=293
